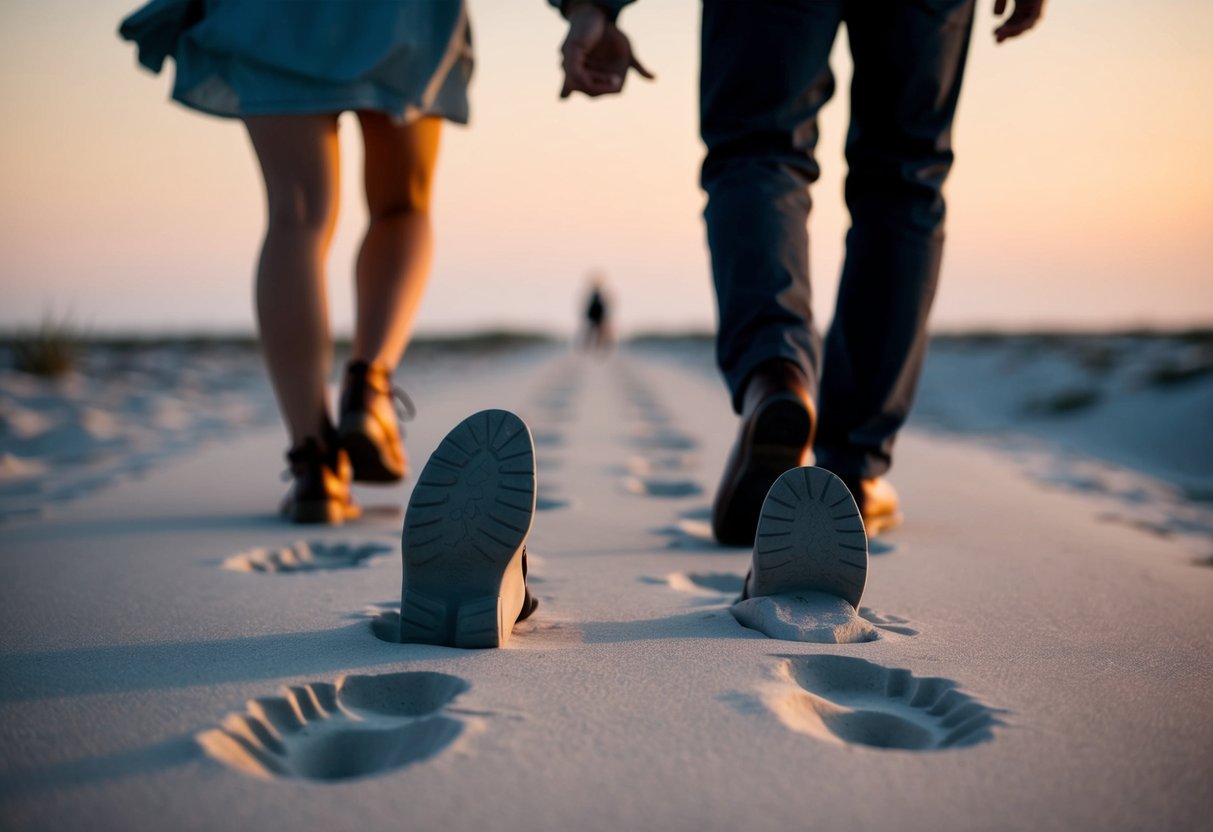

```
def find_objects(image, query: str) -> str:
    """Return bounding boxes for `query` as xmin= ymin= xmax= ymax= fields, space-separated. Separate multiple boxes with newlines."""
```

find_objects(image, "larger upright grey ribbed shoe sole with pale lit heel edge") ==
xmin=400 ymin=410 xmax=535 ymax=648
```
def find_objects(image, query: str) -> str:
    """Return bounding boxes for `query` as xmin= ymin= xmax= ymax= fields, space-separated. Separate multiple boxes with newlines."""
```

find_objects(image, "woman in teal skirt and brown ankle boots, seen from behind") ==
xmin=120 ymin=0 xmax=472 ymax=524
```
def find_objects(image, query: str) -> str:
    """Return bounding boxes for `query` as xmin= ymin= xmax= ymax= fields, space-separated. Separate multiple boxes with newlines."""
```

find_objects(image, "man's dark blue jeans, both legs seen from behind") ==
xmin=700 ymin=0 xmax=974 ymax=477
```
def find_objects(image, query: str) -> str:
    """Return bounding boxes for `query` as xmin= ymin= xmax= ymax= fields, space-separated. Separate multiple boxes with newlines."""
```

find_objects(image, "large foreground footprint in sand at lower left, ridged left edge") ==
xmin=197 ymin=672 xmax=469 ymax=781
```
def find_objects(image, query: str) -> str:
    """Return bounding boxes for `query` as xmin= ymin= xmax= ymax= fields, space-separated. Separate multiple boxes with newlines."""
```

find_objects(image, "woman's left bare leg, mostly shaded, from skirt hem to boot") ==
xmin=245 ymin=114 xmax=340 ymax=445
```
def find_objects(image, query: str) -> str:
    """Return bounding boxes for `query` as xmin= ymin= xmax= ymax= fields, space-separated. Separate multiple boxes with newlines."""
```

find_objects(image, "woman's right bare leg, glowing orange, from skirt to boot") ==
xmin=352 ymin=112 xmax=442 ymax=370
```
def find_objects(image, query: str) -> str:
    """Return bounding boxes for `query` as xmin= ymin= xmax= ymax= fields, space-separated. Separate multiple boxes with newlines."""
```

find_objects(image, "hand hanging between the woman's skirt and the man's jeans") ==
xmin=560 ymin=2 xmax=654 ymax=98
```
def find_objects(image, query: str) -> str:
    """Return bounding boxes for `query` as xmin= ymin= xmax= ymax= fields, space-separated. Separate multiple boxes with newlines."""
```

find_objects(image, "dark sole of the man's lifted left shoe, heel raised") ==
xmin=712 ymin=394 xmax=813 ymax=546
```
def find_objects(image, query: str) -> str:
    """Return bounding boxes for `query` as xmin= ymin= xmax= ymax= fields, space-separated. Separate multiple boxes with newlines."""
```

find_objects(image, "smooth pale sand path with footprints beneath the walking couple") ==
xmin=0 ymin=342 xmax=1213 ymax=832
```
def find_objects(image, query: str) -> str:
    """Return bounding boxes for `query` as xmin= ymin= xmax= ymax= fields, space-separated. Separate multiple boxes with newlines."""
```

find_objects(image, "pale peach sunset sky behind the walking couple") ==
xmin=0 ymin=0 xmax=1213 ymax=334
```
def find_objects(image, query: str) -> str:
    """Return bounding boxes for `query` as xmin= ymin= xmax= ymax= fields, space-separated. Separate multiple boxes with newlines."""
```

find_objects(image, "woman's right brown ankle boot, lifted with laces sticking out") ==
xmin=337 ymin=361 xmax=408 ymax=483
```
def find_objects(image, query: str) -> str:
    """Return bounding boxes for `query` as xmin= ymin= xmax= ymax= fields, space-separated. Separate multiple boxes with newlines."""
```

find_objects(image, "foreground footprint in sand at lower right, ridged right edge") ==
xmin=763 ymin=655 xmax=1002 ymax=751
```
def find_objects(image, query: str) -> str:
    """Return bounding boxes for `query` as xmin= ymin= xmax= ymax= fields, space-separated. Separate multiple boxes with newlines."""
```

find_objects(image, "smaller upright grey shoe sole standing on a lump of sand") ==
xmin=750 ymin=467 xmax=867 ymax=609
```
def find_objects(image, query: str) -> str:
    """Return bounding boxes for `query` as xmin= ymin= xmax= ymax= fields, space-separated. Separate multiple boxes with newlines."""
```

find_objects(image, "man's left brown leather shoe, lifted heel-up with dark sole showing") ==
xmin=712 ymin=360 xmax=816 ymax=546
